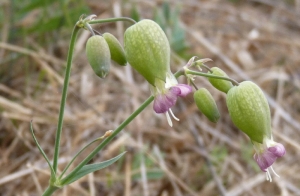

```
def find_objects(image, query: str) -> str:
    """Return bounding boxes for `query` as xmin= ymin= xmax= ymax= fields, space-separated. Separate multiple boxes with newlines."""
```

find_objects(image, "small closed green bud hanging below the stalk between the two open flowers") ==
xmin=194 ymin=88 xmax=220 ymax=123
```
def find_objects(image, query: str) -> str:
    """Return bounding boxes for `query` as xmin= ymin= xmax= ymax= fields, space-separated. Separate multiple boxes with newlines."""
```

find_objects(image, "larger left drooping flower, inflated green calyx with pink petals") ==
xmin=124 ymin=20 xmax=192 ymax=126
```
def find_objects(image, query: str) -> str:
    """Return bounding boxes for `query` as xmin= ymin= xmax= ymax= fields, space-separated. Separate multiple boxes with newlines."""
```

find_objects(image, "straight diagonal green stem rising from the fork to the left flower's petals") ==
xmin=60 ymin=96 xmax=154 ymax=186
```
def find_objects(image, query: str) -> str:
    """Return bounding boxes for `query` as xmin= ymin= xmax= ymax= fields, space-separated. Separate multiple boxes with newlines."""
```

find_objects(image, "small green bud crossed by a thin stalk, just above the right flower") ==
xmin=208 ymin=67 xmax=233 ymax=93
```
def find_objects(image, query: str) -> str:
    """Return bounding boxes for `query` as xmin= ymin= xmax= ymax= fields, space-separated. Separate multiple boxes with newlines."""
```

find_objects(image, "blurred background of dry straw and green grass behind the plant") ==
xmin=0 ymin=0 xmax=300 ymax=196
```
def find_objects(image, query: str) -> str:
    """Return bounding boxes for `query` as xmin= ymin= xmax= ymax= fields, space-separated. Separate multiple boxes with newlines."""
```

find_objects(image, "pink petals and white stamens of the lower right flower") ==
xmin=252 ymin=138 xmax=285 ymax=182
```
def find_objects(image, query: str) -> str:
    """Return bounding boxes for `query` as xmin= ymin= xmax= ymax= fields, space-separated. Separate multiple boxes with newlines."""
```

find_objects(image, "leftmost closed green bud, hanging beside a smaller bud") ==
xmin=86 ymin=35 xmax=110 ymax=78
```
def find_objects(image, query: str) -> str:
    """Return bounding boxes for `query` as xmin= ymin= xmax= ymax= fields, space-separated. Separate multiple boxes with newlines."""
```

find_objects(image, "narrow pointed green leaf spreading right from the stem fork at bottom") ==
xmin=63 ymin=152 xmax=126 ymax=185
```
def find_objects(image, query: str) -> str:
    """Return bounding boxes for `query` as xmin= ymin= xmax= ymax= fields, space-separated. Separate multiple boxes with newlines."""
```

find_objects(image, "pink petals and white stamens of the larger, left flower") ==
xmin=150 ymin=72 xmax=192 ymax=127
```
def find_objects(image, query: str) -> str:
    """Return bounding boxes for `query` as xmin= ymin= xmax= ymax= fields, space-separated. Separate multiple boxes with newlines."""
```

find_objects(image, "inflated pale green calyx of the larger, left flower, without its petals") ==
xmin=124 ymin=20 xmax=170 ymax=86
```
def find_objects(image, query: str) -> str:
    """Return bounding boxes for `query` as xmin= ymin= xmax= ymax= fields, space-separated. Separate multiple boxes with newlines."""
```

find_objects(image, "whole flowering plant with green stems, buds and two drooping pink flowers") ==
xmin=31 ymin=15 xmax=285 ymax=196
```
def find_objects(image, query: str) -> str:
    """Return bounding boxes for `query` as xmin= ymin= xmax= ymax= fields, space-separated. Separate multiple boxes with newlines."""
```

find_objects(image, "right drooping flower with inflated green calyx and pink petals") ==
xmin=226 ymin=81 xmax=285 ymax=182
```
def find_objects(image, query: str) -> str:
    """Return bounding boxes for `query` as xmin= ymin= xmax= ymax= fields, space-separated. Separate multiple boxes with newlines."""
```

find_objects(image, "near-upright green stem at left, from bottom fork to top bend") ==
xmin=53 ymin=25 xmax=80 ymax=173
